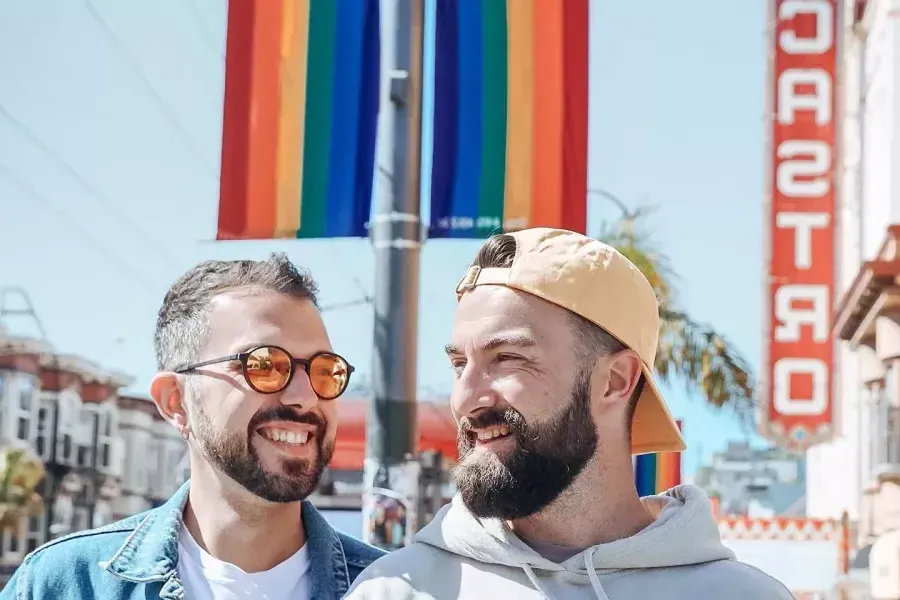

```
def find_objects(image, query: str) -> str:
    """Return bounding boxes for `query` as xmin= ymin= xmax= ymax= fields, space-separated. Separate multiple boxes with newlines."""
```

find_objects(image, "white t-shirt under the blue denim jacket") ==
xmin=177 ymin=526 xmax=311 ymax=600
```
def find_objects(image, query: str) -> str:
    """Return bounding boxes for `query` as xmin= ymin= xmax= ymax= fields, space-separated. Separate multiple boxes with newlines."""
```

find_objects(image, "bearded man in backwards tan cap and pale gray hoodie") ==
xmin=348 ymin=228 xmax=792 ymax=600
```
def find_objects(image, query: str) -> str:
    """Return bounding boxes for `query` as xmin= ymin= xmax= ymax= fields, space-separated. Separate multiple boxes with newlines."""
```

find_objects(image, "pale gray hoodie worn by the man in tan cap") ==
xmin=345 ymin=486 xmax=793 ymax=600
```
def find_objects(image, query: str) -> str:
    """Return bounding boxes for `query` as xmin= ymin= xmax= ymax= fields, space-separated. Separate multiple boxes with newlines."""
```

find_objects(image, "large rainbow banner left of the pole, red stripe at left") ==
xmin=216 ymin=0 xmax=381 ymax=240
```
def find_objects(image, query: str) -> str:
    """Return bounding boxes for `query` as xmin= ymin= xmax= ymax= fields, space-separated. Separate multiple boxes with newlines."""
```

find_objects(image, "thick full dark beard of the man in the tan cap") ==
xmin=453 ymin=372 xmax=597 ymax=520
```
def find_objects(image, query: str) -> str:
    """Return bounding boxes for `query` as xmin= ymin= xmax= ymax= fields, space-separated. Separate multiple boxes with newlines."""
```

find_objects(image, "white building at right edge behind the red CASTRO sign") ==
xmin=807 ymin=0 xmax=900 ymax=599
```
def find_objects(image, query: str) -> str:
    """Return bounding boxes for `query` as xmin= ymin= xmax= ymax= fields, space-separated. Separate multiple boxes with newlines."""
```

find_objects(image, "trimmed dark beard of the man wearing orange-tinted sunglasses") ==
xmin=191 ymin=399 xmax=334 ymax=502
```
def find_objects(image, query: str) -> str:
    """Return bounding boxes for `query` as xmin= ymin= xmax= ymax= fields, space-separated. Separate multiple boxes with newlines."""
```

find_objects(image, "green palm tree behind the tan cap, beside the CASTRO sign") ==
xmin=598 ymin=208 xmax=756 ymax=422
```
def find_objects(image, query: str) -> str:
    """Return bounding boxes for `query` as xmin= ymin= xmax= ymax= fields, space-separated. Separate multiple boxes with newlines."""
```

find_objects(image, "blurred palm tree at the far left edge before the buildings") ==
xmin=0 ymin=446 xmax=44 ymax=529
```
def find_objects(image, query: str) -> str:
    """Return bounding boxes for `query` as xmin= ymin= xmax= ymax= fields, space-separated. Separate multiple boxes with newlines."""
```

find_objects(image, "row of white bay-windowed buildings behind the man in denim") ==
xmin=0 ymin=327 xmax=186 ymax=584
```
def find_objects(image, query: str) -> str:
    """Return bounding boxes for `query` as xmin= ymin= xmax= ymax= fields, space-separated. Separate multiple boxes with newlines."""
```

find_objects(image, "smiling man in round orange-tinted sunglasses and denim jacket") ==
xmin=0 ymin=255 xmax=384 ymax=600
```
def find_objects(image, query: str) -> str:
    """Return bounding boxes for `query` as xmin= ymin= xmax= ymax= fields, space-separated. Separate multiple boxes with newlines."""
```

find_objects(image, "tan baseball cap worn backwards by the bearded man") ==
xmin=456 ymin=227 xmax=687 ymax=454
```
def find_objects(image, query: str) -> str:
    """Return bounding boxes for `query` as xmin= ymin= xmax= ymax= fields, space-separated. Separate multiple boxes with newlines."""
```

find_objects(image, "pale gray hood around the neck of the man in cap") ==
xmin=416 ymin=485 xmax=735 ymax=600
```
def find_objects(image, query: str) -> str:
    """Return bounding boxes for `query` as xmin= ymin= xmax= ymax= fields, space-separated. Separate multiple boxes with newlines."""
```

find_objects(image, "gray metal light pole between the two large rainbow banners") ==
xmin=363 ymin=0 xmax=424 ymax=547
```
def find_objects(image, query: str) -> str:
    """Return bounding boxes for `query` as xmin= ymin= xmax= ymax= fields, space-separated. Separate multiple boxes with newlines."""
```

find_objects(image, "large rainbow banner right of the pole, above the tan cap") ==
xmin=429 ymin=0 xmax=589 ymax=238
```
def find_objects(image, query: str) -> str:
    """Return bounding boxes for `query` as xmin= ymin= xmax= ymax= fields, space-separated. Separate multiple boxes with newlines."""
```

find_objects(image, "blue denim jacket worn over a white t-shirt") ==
xmin=0 ymin=483 xmax=384 ymax=600
